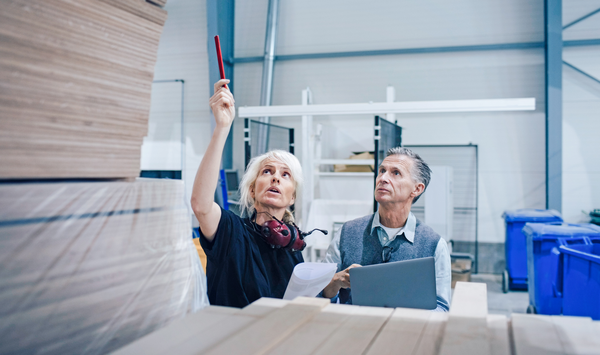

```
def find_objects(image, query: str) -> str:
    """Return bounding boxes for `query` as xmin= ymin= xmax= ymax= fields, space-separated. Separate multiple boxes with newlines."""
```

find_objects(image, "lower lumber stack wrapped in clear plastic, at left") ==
xmin=0 ymin=179 xmax=208 ymax=354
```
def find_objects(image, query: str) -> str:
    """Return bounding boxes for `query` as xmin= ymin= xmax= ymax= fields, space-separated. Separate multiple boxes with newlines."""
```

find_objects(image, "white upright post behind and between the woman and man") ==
xmin=300 ymin=88 xmax=315 ymax=228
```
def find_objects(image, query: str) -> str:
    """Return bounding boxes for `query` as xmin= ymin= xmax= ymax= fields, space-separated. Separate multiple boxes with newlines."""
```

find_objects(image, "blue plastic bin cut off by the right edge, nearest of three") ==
xmin=560 ymin=239 xmax=600 ymax=320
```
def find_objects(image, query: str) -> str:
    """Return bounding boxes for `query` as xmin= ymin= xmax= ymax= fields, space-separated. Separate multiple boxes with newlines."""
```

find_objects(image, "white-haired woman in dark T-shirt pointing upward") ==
xmin=191 ymin=79 xmax=303 ymax=307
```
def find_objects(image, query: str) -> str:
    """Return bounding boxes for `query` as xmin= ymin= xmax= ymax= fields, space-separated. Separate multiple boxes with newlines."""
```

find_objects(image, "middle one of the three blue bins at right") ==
xmin=523 ymin=223 xmax=600 ymax=315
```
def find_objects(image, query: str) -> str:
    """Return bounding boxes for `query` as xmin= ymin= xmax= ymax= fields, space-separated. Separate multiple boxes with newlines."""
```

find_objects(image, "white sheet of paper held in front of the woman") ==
xmin=283 ymin=263 xmax=337 ymax=300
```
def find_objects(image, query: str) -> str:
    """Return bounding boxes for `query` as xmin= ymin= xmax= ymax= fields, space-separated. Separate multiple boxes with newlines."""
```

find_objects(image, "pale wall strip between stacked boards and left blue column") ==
xmin=142 ymin=0 xmax=211 ymax=214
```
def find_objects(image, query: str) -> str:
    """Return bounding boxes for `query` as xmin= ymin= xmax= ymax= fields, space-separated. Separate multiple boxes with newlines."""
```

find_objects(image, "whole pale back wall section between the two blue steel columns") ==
xmin=235 ymin=0 xmax=545 ymax=242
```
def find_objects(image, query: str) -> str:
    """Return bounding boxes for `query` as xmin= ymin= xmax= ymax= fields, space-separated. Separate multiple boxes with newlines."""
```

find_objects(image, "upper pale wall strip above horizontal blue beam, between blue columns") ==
xmin=236 ymin=0 xmax=544 ymax=57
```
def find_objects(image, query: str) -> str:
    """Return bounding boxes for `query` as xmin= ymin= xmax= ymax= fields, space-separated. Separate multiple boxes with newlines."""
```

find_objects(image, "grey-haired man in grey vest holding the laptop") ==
xmin=322 ymin=147 xmax=451 ymax=312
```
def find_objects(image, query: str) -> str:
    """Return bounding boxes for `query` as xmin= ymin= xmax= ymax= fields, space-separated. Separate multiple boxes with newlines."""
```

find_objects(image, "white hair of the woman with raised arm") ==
xmin=240 ymin=150 xmax=304 ymax=223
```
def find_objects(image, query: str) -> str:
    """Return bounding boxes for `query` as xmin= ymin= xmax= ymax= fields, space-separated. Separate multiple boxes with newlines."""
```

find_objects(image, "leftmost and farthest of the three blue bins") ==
xmin=502 ymin=208 xmax=563 ymax=290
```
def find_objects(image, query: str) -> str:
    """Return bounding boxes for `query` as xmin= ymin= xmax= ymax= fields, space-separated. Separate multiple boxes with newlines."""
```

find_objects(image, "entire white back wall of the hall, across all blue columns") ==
xmin=147 ymin=0 xmax=600 ymax=242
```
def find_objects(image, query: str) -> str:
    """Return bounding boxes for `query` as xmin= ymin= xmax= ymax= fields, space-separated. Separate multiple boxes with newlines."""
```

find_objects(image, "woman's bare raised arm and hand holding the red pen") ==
xmin=191 ymin=79 xmax=235 ymax=241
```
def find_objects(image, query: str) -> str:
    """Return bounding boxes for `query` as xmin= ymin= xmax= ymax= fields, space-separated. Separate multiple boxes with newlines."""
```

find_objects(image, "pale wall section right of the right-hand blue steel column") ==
xmin=563 ymin=0 xmax=600 ymax=222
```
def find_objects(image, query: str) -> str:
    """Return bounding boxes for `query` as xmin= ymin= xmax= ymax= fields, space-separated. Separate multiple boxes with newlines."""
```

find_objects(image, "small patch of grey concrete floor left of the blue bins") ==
xmin=454 ymin=274 xmax=529 ymax=316
